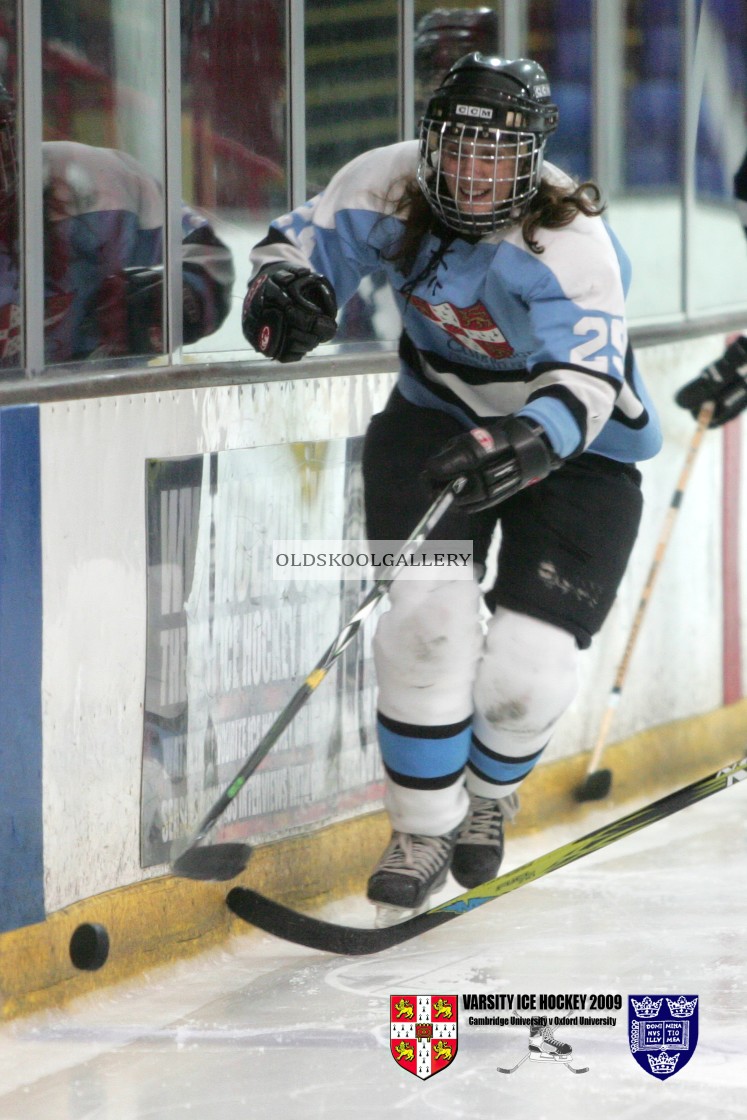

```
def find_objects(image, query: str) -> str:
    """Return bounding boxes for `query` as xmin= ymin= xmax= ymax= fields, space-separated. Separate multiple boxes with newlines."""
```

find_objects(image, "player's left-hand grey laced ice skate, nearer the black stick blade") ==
xmin=366 ymin=829 xmax=457 ymax=927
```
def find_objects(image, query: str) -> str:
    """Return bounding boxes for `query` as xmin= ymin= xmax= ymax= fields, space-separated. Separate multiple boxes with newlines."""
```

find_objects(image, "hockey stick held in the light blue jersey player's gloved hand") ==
xmin=171 ymin=479 xmax=464 ymax=881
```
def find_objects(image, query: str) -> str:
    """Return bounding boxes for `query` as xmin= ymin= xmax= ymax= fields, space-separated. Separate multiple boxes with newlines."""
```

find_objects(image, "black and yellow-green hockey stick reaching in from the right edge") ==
xmin=226 ymin=758 xmax=747 ymax=956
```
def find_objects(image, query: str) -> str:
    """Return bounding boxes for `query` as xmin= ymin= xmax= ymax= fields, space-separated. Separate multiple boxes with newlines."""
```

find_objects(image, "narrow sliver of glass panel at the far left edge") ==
xmin=0 ymin=0 xmax=24 ymax=374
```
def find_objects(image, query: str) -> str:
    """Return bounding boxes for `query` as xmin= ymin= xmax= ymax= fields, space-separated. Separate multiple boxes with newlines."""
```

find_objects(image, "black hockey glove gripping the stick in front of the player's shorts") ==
xmin=426 ymin=417 xmax=561 ymax=513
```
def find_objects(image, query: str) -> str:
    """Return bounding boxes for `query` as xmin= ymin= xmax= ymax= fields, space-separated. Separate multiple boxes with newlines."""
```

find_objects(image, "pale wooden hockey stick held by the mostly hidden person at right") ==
xmin=573 ymin=401 xmax=713 ymax=801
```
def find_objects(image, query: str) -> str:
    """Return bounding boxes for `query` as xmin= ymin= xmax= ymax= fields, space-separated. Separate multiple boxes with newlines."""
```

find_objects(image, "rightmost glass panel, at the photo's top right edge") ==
xmin=688 ymin=0 xmax=747 ymax=312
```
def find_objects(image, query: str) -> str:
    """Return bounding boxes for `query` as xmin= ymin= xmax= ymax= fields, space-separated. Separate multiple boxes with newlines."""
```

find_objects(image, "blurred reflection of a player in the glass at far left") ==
xmin=0 ymin=86 xmax=234 ymax=367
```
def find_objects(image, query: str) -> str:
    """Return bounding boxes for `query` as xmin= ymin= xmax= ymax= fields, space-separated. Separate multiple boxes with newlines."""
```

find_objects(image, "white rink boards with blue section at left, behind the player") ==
xmin=0 ymin=337 xmax=747 ymax=1016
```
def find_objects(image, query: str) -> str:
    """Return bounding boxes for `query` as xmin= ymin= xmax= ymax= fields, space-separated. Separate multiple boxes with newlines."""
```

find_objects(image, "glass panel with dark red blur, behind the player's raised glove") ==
xmin=181 ymin=0 xmax=289 ymax=361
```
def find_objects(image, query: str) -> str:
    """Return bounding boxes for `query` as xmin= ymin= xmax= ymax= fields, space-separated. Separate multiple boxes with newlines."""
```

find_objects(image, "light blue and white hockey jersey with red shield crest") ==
xmin=252 ymin=141 xmax=661 ymax=463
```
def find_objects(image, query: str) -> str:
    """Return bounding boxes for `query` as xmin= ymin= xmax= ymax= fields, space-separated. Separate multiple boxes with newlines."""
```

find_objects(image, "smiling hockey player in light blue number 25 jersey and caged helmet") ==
xmin=243 ymin=53 xmax=661 ymax=914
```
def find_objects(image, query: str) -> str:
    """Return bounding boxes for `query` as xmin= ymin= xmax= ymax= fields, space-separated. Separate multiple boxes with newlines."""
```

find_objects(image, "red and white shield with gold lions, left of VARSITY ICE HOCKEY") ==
xmin=389 ymin=996 xmax=458 ymax=1081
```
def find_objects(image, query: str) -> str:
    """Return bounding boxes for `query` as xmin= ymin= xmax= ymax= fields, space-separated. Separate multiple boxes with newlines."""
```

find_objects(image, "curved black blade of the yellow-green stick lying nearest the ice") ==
xmin=226 ymin=887 xmax=456 ymax=956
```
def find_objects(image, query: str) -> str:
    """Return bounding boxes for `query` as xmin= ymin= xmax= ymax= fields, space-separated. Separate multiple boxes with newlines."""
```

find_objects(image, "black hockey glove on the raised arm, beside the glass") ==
xmin=241 ymin=264 xmax=337 ymax=362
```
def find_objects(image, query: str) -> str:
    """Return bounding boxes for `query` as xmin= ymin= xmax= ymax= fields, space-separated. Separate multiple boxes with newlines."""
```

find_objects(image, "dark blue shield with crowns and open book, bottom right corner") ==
xmin=628 ymin=996 xmax=698 ymax=1081
